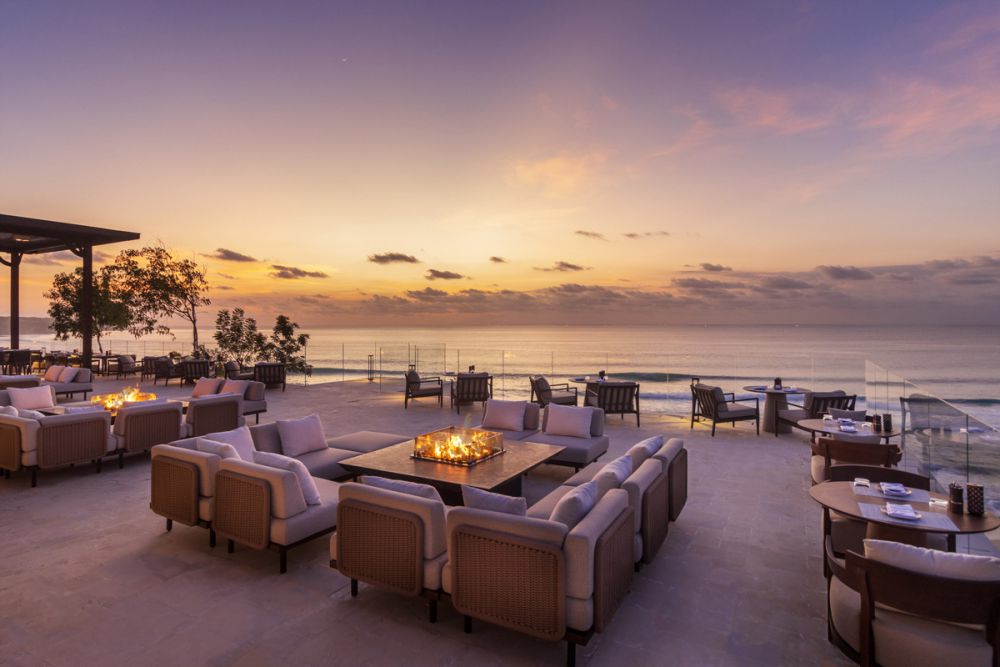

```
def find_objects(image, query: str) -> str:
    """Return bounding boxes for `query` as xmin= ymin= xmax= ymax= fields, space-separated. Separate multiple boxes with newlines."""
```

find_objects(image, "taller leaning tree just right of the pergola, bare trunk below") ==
xmin=114 ymin=246 xmax=212 ymax=352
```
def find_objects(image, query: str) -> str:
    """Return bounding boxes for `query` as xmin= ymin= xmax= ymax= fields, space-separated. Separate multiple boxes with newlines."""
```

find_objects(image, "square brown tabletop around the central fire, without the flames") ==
xmin=340 ymin=440 xmax=564 ymax=505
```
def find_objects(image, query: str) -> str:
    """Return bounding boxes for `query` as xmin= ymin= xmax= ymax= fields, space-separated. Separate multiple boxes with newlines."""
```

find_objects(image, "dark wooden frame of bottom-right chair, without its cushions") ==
xmin=824 ymin=538 xmax=1000 ymax=667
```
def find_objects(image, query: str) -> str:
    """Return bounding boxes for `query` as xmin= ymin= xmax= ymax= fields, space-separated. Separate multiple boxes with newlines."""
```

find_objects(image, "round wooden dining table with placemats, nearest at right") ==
xmin=809 ymin=482 xmax=1000 ymax=551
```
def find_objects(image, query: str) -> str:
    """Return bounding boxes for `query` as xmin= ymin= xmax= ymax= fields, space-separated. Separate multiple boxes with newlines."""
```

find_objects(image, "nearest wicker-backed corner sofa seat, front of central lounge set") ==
xmin=444 ymin=489 xmax=634 ymax=665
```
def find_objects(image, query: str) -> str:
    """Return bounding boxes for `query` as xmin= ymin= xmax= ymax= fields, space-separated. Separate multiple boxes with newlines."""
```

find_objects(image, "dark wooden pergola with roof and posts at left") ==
xmin=0 ymin=213 xmax=139 ymax=368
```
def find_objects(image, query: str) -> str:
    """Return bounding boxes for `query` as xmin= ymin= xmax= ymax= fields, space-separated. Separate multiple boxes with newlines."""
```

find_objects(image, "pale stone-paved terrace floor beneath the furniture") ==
xmin=0 ymin=380 xmax=976 ymax=667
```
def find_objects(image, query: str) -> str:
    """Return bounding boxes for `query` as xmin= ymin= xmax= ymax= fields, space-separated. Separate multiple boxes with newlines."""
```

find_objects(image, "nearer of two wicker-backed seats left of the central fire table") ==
xmin=212 ymin=459 xmax=340 ymax=574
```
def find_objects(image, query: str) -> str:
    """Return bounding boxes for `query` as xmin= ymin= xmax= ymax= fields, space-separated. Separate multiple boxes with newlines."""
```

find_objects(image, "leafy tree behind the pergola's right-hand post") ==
xmin=45 ymin=267 xmax=133 ymax=352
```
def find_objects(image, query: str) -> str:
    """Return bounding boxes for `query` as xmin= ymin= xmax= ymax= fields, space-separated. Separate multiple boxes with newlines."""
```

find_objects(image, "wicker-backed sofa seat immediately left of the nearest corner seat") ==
xmin=330 ymin=482 xmax=448 ymax=623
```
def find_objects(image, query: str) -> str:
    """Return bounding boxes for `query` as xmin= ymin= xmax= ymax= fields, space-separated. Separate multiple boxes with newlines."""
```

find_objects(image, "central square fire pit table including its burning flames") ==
xmin=340 ymin=427 xmax=563 ymax=505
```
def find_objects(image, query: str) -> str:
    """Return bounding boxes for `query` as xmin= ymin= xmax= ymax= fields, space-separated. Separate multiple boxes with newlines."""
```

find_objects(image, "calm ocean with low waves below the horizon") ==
xmin=0 ymin=323 xmax=1000 ymax=426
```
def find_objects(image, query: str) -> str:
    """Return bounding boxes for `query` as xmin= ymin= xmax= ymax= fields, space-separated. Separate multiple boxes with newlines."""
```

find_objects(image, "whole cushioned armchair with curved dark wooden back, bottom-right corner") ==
xmin=826 ymin=539 xmax=1000 ymax=667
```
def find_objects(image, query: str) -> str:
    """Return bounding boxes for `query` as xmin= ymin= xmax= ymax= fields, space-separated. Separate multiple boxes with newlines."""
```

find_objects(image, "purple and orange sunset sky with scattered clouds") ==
xmin=0 ymin=0 xmax=1000 ymax=326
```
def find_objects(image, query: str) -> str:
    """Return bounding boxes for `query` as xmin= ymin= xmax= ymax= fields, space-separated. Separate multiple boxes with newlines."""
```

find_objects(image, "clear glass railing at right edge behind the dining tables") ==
xmin=865 ymin=361 xmax=1000 ymax=512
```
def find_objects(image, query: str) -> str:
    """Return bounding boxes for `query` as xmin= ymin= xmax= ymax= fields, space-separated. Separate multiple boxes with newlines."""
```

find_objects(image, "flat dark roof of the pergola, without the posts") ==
xmin=0 ymin=213 xmax=139 ymax=255
